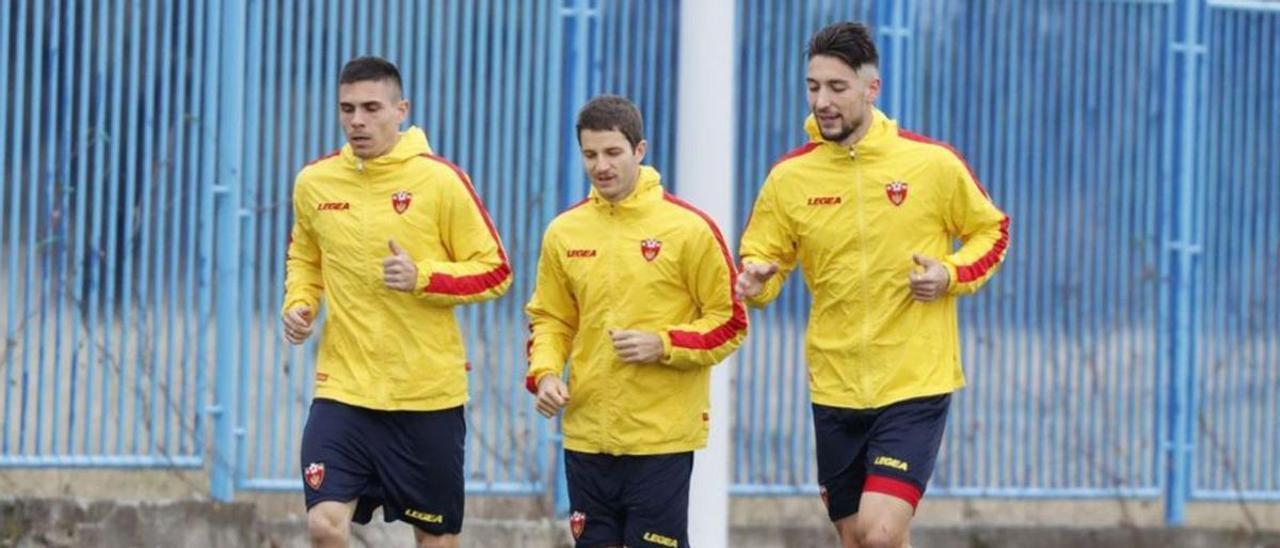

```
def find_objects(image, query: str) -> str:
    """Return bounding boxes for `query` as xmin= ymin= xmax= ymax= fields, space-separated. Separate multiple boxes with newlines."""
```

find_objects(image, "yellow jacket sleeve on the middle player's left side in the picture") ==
xmin=525 ymin=230 xmax=577 ymax=393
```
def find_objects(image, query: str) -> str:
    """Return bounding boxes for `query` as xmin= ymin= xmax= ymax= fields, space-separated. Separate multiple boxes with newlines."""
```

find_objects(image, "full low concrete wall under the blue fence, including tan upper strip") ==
xmin=0 ymin=469 xmax=1280 ymax=548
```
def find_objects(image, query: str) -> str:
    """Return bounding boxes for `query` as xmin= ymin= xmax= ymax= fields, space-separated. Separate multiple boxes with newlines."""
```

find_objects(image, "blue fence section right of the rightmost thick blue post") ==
xmin=1188 ymin=3 xmax=1280 ymax=501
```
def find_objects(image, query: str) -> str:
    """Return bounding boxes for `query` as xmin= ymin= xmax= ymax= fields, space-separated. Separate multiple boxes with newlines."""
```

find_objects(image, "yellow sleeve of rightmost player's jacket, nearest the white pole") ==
xmin=739 ymin=173 xmax=796 ymax=307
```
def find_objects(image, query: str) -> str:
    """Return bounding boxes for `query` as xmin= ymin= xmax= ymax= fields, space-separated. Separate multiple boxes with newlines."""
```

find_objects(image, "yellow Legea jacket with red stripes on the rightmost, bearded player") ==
xmin=741 ymin=110 xmax=1009 ymax=408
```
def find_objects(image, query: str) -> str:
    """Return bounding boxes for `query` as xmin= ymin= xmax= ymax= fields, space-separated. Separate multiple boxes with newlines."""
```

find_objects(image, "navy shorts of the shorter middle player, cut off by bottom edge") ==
xmin=564 ymin=449 xmax=694 ymax=548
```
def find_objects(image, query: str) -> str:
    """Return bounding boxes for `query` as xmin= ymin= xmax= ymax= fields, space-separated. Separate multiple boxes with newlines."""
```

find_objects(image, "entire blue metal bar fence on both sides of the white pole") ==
xmin=0 ymin=0 xmax=1280 ymax=522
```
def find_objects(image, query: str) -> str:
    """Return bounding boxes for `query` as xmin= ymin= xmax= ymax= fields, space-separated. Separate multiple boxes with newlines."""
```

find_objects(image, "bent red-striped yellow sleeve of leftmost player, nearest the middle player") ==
xmin=416 ymin=172 xmax=511 ymax=306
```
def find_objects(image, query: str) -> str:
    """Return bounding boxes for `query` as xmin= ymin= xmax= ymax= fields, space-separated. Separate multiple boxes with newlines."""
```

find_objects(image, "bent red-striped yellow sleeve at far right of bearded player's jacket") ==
xmin=942 ymin=156 xmax=1009 ymax=294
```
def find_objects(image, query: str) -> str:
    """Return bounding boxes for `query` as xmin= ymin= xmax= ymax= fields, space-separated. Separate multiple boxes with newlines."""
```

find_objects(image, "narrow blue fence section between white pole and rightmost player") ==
xmin=731 ymin=0 xmax=872 ymax=496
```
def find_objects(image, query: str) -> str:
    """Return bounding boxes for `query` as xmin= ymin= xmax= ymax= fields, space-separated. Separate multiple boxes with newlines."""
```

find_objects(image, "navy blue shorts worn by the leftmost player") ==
xmin=302 ymin=399 xmax=467 ymax=535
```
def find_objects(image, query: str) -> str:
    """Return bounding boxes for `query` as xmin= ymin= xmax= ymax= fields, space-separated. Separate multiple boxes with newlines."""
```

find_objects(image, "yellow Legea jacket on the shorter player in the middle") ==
xmin=526 ymin=166 xmax=748 ymax=455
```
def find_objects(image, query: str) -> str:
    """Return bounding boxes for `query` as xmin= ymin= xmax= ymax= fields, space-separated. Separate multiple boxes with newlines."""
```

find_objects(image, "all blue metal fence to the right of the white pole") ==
xmin=732 ymin=0 xmax=1280 ymax=522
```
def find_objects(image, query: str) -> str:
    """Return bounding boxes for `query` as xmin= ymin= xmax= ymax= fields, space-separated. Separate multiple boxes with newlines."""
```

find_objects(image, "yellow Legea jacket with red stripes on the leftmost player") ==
xmin=282 ymin=127 xmax=511 ymax=411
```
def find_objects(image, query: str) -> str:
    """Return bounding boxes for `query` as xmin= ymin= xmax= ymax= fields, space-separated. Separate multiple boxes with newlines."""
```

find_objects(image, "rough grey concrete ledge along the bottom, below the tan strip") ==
xmin=0 ymin=498 xmax=1280 ymax=548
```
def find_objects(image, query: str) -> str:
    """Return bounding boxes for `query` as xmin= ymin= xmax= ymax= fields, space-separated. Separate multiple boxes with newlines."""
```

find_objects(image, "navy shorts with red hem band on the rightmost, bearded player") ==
xmin=813 ymin=394 xmax=951 ymax=521
